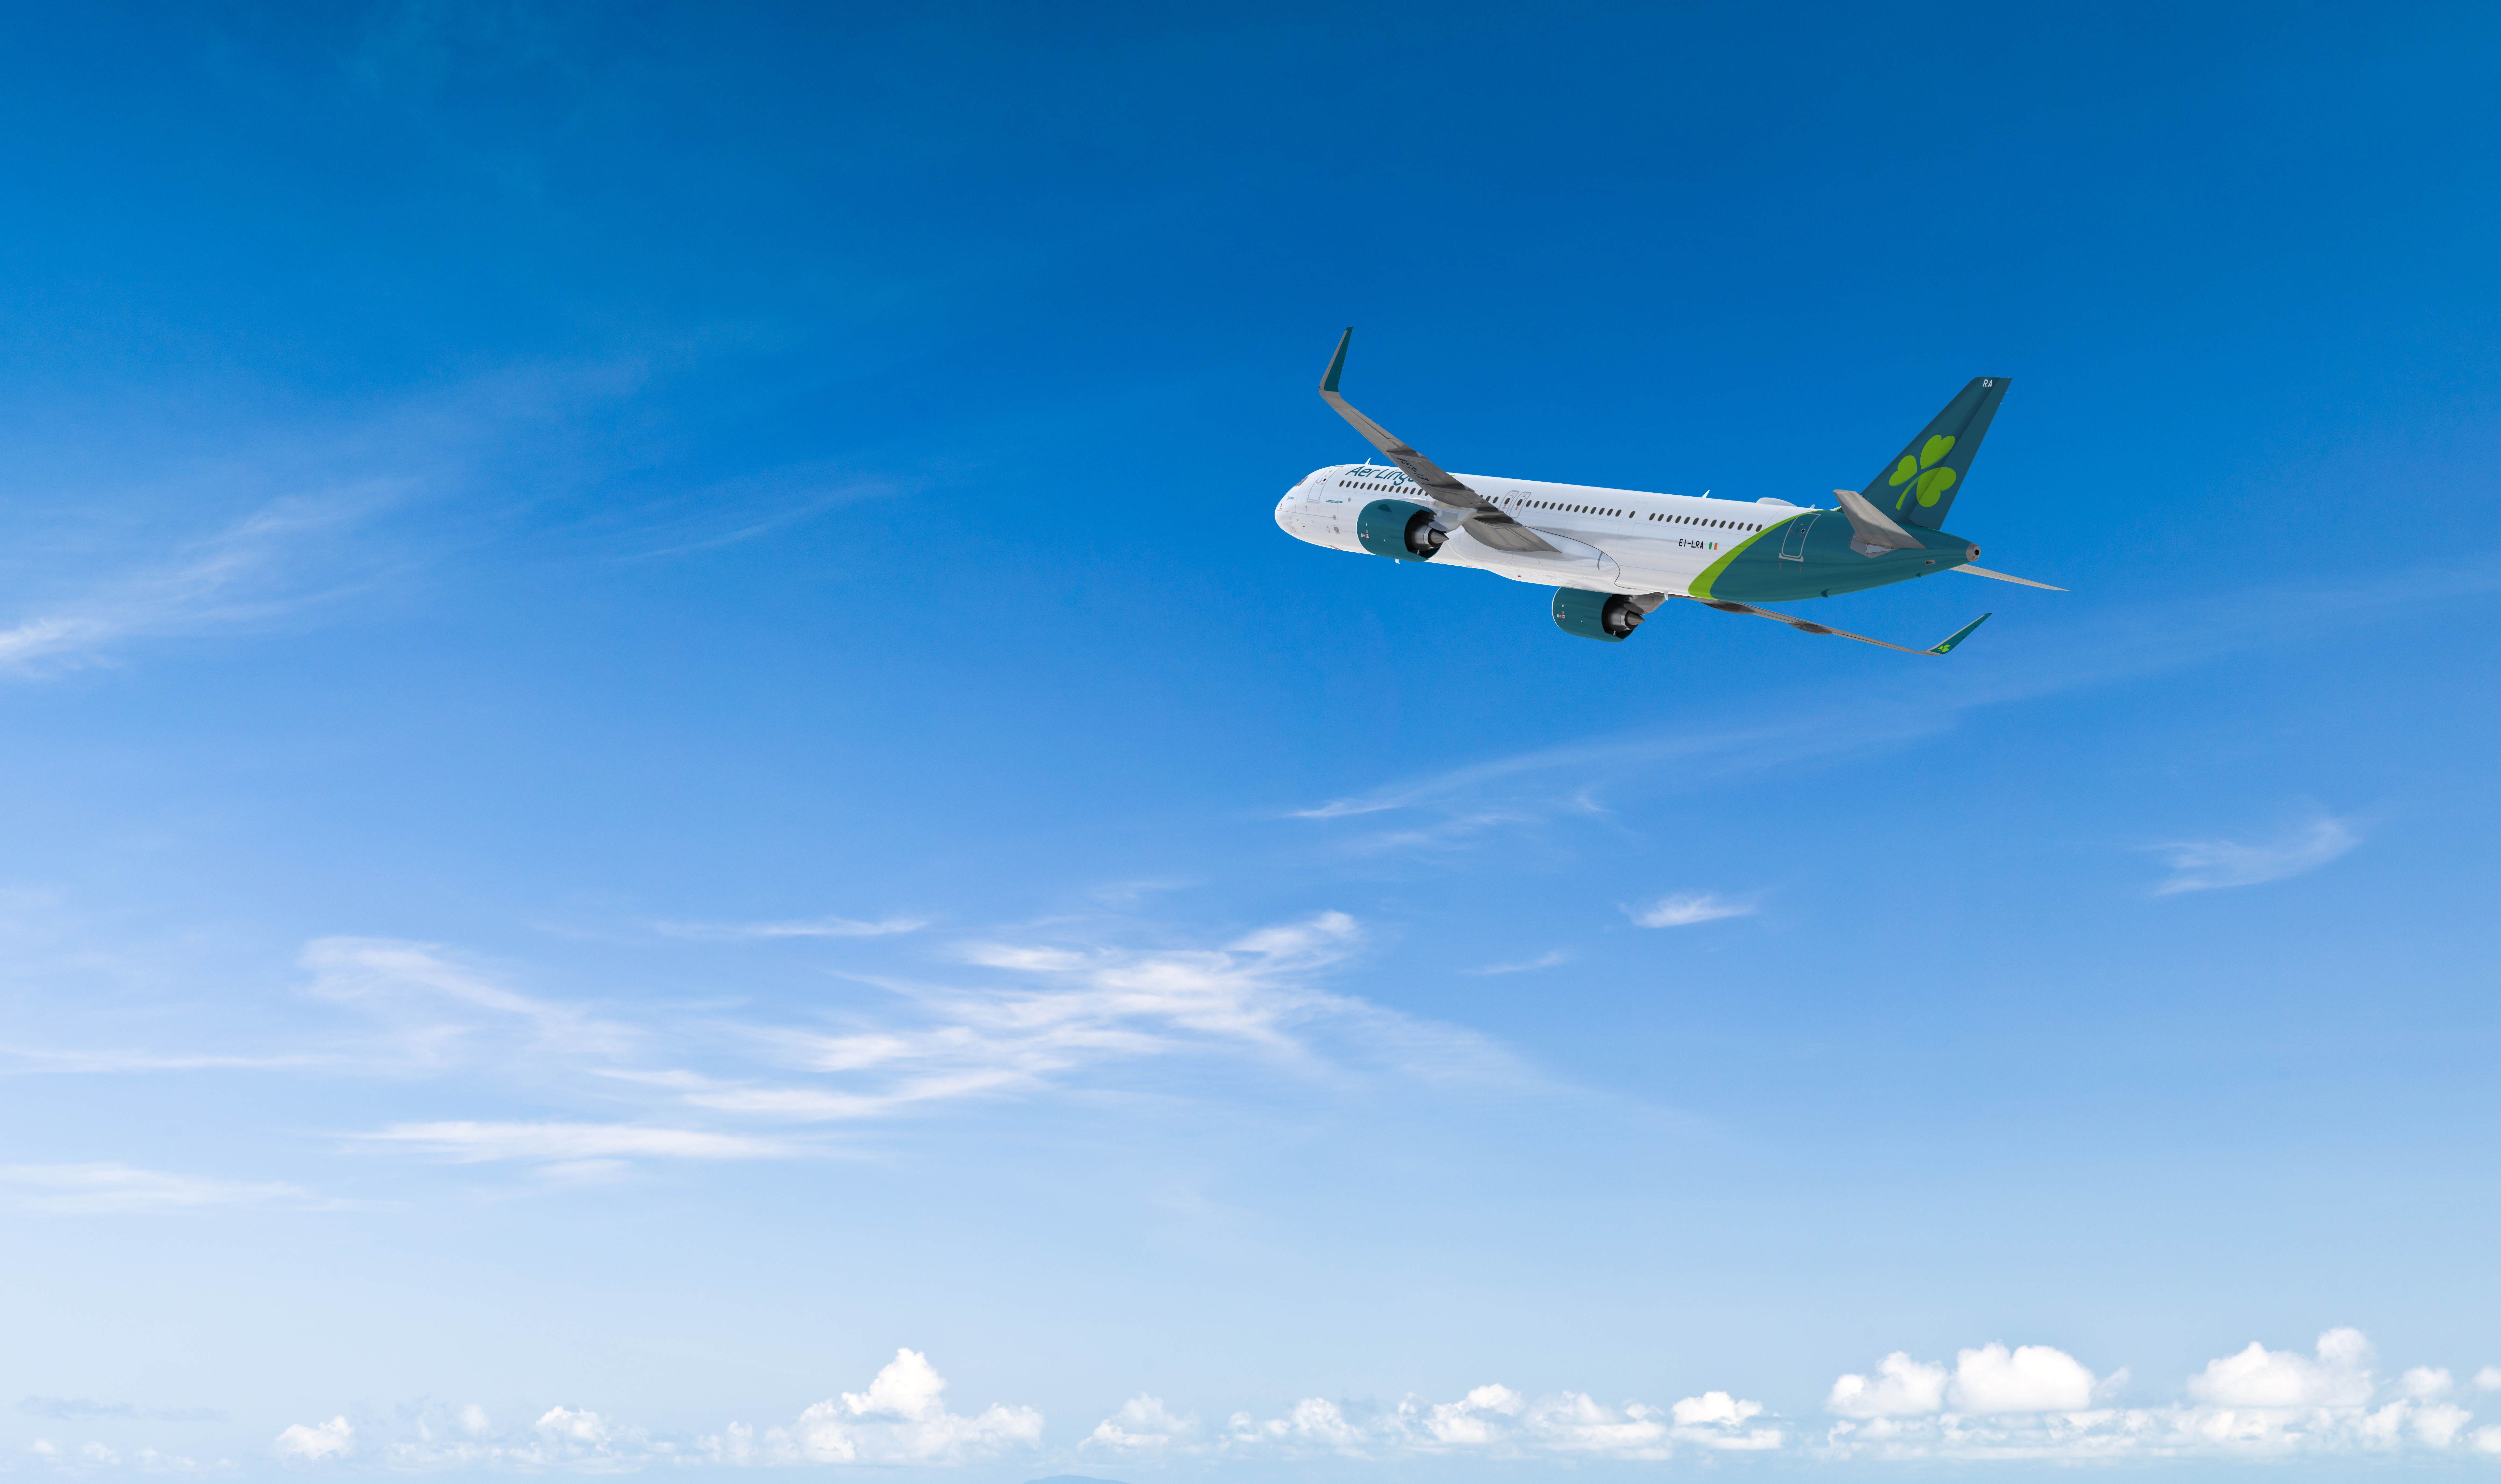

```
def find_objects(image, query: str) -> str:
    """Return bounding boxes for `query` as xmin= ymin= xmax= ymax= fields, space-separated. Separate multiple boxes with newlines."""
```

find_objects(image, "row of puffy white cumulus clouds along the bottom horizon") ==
xmin=235 ymin=1329 xmax=2501 ymax=1474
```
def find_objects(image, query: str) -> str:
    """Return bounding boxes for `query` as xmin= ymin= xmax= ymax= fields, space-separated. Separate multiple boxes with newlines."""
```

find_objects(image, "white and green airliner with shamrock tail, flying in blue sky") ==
xmin=1276 ymin=328 xmax=2066 ymax=656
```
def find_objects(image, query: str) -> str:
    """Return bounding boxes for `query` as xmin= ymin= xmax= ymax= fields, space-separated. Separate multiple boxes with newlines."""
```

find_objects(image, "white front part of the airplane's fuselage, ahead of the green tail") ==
xmin=1276 ymin=463 xmax=1798 ymax=593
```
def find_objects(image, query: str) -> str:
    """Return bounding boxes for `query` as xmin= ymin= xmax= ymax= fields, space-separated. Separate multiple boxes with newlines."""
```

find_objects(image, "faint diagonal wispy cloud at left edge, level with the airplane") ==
xmin=0 ymin=358 xmax=725 ymax=678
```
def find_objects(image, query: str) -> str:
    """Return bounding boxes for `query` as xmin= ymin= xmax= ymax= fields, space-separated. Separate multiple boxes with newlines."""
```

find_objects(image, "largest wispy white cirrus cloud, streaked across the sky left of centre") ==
xmin=335 ymin=911 xmax=1508 ymax=1156
